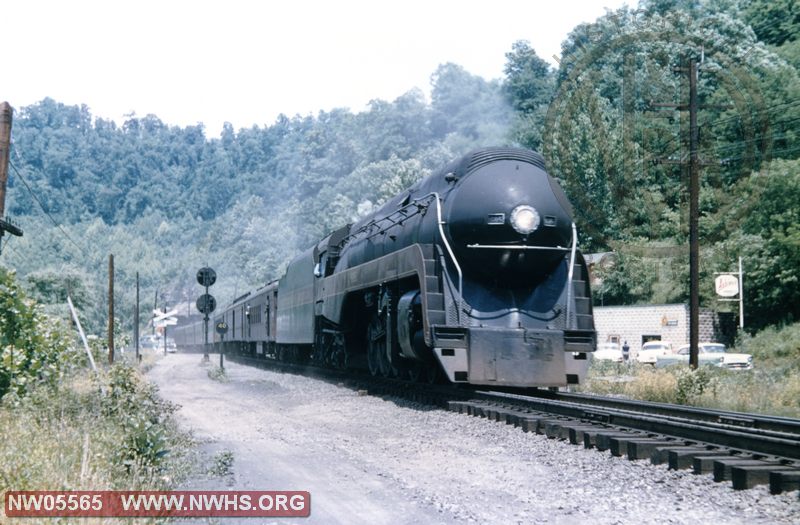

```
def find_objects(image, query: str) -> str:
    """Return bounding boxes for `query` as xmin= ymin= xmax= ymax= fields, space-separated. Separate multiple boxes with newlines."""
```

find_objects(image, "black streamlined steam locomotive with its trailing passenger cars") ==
xmin=173 ymin=148 xmax=596 ymax=387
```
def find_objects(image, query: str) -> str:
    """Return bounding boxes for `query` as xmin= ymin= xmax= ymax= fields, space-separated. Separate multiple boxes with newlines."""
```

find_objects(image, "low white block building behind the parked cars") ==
xmin=594 ymin=304 xmax=736 ymax=359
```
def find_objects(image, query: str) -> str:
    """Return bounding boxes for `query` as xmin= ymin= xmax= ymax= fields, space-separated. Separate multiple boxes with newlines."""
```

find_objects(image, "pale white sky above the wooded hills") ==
xmin=0 ymin=0 xmax=635 ymax=137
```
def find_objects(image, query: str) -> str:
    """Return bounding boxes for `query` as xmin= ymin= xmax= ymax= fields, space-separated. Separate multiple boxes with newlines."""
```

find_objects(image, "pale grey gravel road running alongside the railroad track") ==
xmin=148 ymin=354 xmax=800 ymax=525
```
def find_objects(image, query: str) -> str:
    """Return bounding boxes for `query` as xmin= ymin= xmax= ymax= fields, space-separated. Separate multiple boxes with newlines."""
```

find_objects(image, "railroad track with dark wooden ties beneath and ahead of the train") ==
xmin=223 ymin=355 xmax=800 ymax=494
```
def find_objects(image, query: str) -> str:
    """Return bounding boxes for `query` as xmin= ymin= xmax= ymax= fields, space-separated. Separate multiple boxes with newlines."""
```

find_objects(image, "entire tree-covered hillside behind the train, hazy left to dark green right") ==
xmin=0 ymin=0 xmax=800 ymax=330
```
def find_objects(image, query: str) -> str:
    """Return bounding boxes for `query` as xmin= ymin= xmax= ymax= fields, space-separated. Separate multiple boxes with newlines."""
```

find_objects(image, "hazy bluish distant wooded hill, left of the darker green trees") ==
xmin=3 ymin=64 xmax=512 ymax=336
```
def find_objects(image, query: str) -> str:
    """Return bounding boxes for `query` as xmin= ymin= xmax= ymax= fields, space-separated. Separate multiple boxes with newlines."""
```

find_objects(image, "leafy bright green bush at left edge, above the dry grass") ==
xmin=0 ymin=268 xmax=80 ymax=396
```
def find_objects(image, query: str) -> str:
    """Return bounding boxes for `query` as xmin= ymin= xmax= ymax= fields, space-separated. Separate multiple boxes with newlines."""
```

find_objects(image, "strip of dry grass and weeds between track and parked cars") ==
xmin=580 ymin=323 xmax=800 ymax=418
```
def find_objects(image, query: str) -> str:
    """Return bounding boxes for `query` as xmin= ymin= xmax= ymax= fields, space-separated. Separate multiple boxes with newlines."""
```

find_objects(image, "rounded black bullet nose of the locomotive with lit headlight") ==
xmin=445 ymin=160 xmax=572 ymax=286
